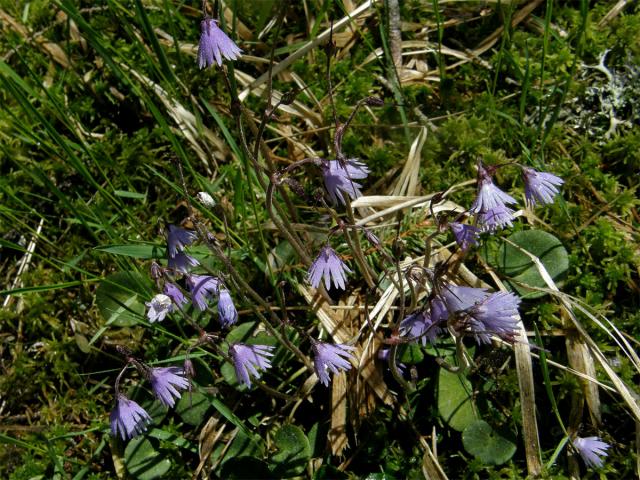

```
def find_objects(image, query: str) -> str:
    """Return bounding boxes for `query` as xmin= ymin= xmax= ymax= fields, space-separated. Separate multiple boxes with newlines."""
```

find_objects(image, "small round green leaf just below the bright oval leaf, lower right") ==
xmin=462 ymin=420 xmax=516 ymax=465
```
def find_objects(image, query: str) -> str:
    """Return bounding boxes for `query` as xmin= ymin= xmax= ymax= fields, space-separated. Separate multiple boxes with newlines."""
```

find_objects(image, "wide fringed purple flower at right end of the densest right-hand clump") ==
xmin=468 ymin=292 xmax=520 ymax=343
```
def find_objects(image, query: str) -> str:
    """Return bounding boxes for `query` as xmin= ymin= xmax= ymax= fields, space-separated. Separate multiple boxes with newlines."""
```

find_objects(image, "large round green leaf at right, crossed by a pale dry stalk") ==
xmin=489 ymin=230 xmax=569 ymax=298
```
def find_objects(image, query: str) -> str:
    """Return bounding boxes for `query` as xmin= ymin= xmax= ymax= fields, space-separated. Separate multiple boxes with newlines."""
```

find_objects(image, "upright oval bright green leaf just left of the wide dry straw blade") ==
xmin=438 ymin=368 xmax=477 ymax=432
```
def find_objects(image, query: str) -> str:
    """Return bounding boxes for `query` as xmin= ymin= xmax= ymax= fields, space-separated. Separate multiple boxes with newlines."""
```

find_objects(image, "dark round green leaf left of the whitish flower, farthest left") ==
xmin=96 ymin=272 xmax=150 ymax=327
